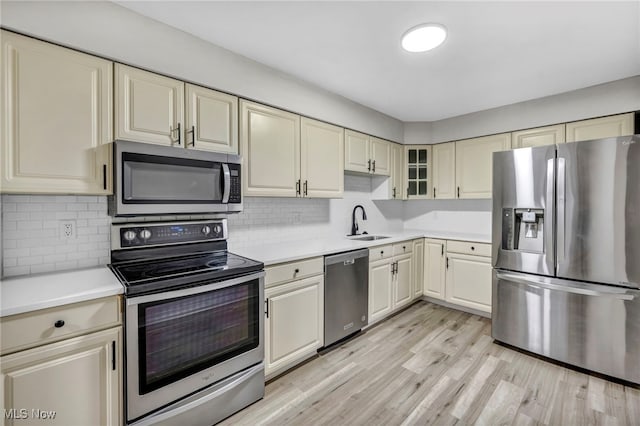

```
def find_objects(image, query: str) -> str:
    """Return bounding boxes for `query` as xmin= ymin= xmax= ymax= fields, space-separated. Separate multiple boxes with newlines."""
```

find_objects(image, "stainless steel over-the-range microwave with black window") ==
xmin=109 ymin=141 xmax=242 ymax=216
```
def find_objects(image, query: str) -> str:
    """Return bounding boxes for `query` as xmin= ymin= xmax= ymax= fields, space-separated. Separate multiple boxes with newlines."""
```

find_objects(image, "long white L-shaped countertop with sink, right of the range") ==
xmin=230 ymin=229 xmax=491 ymax=266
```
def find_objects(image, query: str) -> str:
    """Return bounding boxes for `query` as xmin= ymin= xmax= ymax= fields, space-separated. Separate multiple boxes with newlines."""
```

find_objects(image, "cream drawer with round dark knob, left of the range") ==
xmin=0 ymin=296 xmax=121 ymax=355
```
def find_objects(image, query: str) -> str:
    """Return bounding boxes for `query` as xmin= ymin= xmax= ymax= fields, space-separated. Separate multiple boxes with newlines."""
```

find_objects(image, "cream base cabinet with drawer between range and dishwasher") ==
xmin=265 ymin=257 xmax=324 ymax=379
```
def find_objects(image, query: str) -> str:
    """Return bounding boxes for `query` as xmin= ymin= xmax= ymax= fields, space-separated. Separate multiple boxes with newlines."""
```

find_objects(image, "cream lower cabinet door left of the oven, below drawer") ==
xmin=0 ymin=327 xmax=123 ymax=426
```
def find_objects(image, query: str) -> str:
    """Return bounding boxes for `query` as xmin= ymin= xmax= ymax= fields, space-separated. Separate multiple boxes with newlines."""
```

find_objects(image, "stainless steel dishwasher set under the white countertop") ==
xmin=324 ymin=249 xmax=369 ymax=347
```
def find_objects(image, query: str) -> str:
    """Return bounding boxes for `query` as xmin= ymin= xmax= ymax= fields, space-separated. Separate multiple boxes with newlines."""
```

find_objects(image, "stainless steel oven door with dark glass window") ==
xmin=125 ymin=272 xmax=264 ymax=422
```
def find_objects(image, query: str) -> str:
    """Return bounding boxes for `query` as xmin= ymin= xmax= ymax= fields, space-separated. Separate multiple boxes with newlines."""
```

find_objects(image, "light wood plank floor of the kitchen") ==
xmin=223 ymin=301 xmax=640 ymax=426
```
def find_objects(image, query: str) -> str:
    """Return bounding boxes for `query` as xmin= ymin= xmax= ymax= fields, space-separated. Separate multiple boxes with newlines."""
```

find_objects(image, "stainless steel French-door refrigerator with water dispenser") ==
xmin=492 ymin=135 xmax=640 ymax=383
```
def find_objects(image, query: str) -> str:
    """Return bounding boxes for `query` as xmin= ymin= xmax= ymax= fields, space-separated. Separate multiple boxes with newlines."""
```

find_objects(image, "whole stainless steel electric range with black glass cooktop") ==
xmin=110 ymin=219 xmax=264 ymax=425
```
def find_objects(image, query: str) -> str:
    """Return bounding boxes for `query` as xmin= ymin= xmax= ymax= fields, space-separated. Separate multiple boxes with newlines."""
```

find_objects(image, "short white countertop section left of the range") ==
xmin=0 ymin=266 xmax=124 ymax=317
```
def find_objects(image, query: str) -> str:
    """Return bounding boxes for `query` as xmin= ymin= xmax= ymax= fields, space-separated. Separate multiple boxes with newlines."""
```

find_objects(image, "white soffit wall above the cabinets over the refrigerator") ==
xmin=404 ymin=76 xmax=640 ymax=143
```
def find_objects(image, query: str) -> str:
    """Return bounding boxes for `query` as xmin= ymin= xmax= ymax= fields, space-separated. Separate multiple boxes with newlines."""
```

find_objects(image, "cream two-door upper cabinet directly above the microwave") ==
xmin=115 ymin=64 xmax=238 ymax=153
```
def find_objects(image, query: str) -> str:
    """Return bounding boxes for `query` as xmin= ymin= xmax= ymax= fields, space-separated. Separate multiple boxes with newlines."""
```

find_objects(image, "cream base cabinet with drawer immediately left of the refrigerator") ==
xmin=445 ymin=241 xmax=492 ymax=313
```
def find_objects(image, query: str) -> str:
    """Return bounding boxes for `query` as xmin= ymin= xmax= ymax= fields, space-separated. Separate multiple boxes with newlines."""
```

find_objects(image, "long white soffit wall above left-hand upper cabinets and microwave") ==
xmin=0 ymin=1 xmax=403 ymax=142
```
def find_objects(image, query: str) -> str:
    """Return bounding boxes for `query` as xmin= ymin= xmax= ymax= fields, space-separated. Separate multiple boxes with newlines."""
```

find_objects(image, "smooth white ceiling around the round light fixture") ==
xmin=118 ymin=1 xmax=640 ymax=121
